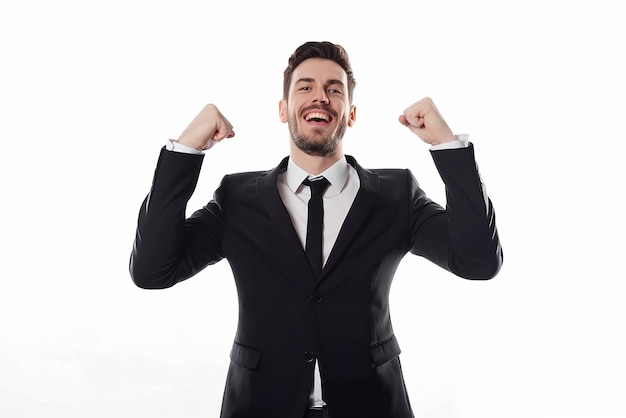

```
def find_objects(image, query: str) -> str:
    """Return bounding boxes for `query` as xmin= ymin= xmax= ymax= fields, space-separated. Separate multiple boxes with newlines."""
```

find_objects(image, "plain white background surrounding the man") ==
xmin=0 ymin=0 xmax=626 ymax=418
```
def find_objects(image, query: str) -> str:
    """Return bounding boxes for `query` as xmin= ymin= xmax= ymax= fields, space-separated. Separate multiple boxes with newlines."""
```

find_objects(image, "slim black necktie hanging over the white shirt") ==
xmin=302 ymin=177 xmax=330 ymax=276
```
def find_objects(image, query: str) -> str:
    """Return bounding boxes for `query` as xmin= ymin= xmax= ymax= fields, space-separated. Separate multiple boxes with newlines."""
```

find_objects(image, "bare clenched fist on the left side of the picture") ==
xmin=177 ymin=104 xmax=235 ymax=151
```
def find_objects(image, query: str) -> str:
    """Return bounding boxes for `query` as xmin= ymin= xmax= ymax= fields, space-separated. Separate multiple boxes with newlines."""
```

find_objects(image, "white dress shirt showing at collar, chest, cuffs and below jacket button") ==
xmin=166 ymin=135 xmax=468 ymax=407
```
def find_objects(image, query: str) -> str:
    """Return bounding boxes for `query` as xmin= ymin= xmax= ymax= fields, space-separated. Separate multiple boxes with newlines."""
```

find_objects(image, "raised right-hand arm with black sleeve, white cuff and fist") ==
xmin=398 ymin=98 xmax=503 ymax=279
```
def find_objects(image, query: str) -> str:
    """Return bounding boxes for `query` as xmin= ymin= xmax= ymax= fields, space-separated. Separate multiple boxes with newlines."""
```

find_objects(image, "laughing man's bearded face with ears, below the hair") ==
xmin=279 ymin=58 xmax=356 ymax=156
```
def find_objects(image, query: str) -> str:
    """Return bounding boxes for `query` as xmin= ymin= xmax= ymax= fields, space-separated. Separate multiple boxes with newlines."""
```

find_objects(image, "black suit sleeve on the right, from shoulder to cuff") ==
xmin=410 ymin=143 xmax=503 ymax=279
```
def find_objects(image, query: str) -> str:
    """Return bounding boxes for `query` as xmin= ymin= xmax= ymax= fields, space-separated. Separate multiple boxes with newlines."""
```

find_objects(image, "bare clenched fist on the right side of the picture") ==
xmin=398 ymin=97 xmax=456 ymax=145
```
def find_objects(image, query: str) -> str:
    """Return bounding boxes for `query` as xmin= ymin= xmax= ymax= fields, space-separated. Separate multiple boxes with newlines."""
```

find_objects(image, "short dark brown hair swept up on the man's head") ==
xmin=283 ymin=41 xmax=356 ymax=103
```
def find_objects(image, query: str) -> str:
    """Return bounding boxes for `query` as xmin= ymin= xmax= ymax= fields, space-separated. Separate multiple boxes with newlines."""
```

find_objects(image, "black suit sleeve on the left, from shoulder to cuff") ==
xmin=129 ymin=148 xmax=223 ymax=289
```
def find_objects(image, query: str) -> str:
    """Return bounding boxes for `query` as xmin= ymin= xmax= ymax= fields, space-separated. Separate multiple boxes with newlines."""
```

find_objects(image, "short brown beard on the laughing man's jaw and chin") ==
xmin=288 ymin=108 xmax=348 ymax=157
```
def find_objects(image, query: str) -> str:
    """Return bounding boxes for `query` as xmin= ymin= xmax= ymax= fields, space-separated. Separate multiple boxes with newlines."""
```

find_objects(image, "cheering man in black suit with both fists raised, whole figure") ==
xmin=130 ymin=42 xmax=502 ymax=418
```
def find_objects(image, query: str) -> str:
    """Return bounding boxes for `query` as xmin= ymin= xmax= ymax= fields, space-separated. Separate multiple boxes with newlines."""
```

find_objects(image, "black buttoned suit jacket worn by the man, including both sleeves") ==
xmin=130 ymin=144 xmax=502 ymax=418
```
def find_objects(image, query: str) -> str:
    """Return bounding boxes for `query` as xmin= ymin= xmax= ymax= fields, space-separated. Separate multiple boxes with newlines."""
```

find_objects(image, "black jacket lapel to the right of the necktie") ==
xmin=320 ymin=155 xmax=379 ymax=280
